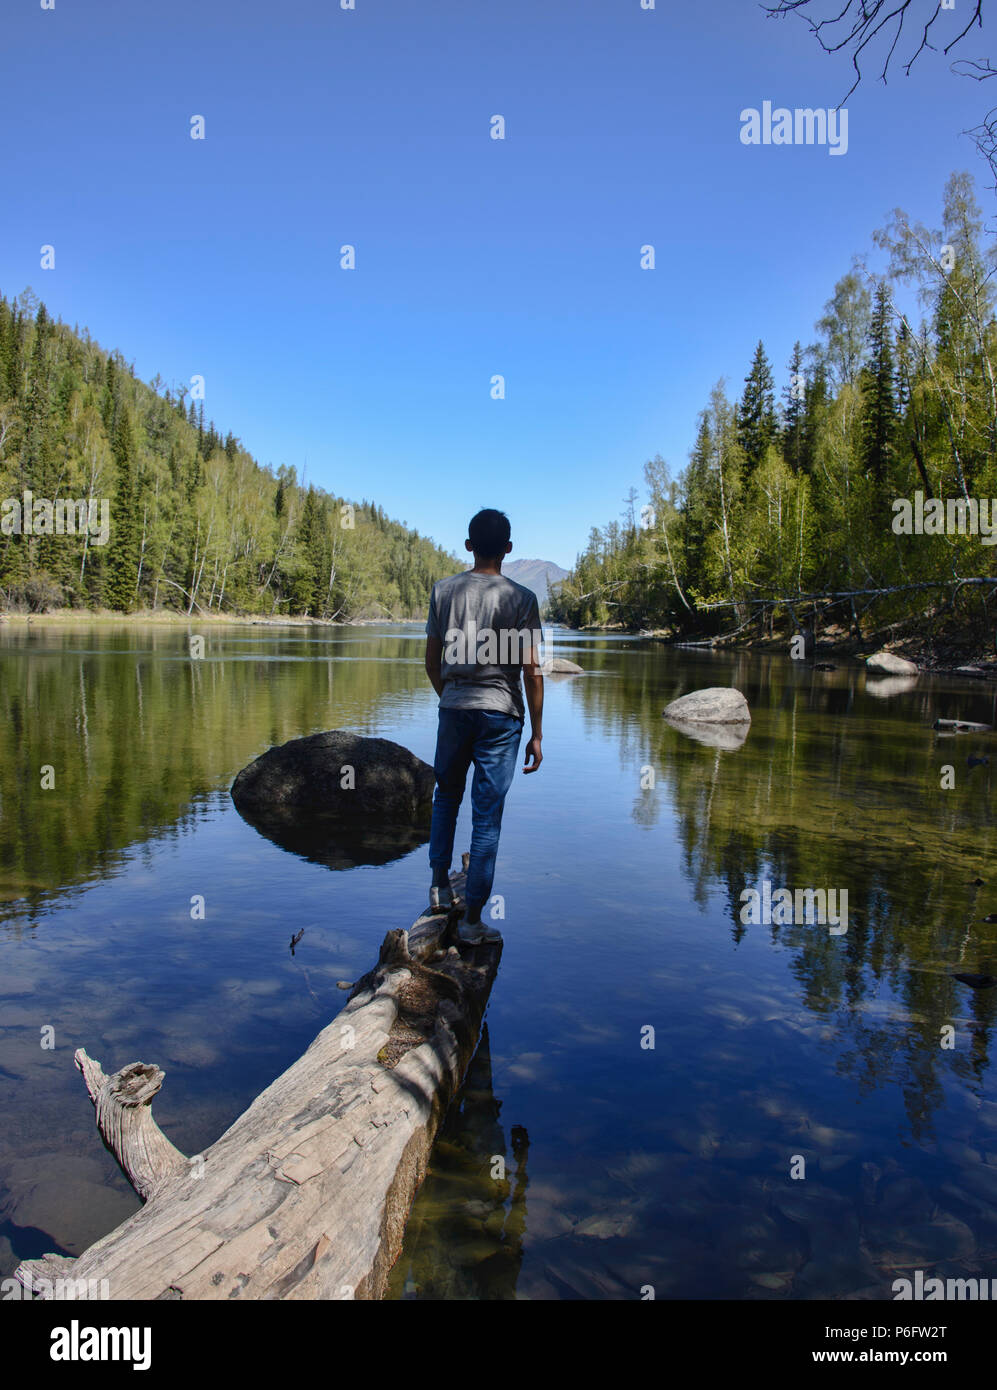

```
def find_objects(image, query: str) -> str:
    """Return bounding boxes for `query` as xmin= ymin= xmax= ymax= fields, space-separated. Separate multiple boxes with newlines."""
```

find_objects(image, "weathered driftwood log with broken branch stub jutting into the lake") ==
xmin=18 ymin=856 xmax=502 ymax=1300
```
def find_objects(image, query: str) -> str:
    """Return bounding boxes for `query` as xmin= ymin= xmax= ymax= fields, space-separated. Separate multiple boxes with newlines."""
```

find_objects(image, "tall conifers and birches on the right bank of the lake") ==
xmin=553 ymin=174 xmax=997 ymax=635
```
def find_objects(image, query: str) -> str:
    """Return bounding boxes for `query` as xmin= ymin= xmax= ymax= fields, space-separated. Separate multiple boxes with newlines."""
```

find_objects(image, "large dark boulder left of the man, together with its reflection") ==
xmin=232 ymin=728 xmax=435 ymax=869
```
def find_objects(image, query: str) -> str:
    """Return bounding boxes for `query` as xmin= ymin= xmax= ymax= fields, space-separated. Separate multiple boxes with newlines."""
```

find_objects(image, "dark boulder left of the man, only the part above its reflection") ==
xmin=232 ymin=728 xmax=434 ymax=831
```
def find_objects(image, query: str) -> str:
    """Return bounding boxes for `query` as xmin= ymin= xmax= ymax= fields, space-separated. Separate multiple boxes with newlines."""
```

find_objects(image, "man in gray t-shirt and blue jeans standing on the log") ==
xmin=425 ymin=507 xmax=544 ymax=945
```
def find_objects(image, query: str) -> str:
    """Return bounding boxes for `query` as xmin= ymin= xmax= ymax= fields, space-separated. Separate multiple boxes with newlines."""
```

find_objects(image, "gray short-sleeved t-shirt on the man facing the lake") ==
xmin=425 ymin=570 xmax=542 ymax=720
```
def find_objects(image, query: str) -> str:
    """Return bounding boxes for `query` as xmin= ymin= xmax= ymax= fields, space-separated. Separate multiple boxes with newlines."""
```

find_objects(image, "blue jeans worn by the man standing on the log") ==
xmin=430 ymin=709 xmax=523 ymax=915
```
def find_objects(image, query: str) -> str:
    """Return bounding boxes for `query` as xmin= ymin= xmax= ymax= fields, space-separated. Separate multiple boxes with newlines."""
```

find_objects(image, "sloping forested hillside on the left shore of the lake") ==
xmin=0 ymin=291 xmax=462 ymax=620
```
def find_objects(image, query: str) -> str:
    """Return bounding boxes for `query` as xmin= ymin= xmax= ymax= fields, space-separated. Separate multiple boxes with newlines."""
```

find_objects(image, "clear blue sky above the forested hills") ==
xmin=0 ymin=0 xmax=978 ymax=566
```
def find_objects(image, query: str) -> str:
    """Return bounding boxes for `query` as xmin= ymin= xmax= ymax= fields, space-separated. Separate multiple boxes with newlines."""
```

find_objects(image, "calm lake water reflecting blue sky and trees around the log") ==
xmin=0 ymin=627 xmax=997 ymax=1300
